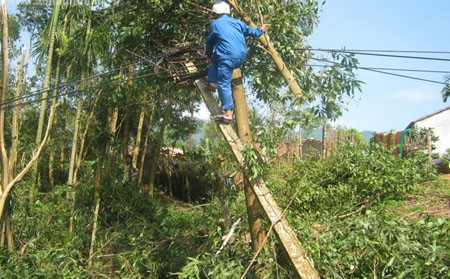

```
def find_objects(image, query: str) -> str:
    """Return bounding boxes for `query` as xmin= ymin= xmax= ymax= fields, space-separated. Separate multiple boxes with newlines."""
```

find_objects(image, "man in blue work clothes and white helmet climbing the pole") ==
xmin=205 ymin=1 xmax=267 ymax=124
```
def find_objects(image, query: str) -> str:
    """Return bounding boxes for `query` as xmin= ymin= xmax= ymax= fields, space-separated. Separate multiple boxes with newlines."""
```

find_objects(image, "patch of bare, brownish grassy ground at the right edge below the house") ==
xmin=396 ymin=174 xmax=450 ymax=219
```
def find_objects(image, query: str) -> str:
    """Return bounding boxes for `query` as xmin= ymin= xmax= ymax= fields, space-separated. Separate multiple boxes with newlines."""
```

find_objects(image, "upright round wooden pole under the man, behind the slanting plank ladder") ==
xmin=232 ymin=69 xmax=266 ymax=278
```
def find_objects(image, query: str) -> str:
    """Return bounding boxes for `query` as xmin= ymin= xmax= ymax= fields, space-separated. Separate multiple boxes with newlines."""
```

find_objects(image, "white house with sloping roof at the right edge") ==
xmin=406 ymin=106 xmax=450 ymax=155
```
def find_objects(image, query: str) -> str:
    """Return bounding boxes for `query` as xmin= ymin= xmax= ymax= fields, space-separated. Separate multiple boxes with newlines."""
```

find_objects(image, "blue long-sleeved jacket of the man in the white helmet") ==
xmin=205 ymin=14 xmax=264 ymax=59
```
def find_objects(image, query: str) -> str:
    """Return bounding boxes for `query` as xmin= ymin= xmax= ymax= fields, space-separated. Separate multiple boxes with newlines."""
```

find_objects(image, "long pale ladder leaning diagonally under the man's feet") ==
xmin=192 ymin=78 xmax=319 ymax=278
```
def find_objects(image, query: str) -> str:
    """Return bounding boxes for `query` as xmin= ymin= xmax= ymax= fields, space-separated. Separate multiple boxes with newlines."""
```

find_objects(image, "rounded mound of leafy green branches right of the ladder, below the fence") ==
xmin=278 ymin=145 xmax=431 ymax=217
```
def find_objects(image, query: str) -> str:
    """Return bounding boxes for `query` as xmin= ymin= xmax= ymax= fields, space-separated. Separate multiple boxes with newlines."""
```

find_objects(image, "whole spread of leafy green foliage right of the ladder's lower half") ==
xmin=267 ymin=145 xmax=450 ymax=278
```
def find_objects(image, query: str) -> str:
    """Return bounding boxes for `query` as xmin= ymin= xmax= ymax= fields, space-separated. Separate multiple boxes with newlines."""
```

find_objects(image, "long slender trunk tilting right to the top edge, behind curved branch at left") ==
xmin=29 ymin=0 xmax=62 ymax=208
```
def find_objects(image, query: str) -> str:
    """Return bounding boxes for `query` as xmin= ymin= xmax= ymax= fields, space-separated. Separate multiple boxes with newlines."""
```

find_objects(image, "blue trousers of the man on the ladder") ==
xmin=207 ymin=56 xmax=245 ymax=110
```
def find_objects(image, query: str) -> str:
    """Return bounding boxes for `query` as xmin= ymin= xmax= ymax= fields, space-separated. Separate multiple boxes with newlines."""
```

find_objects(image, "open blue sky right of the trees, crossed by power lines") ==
xmin=308 ymin=0 xmax=450 ymax=131
